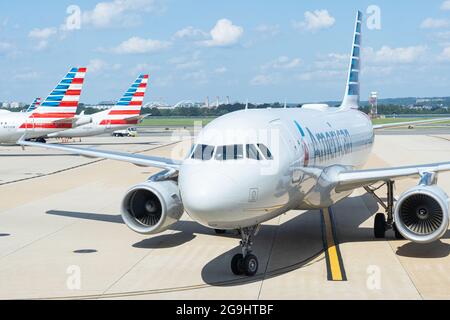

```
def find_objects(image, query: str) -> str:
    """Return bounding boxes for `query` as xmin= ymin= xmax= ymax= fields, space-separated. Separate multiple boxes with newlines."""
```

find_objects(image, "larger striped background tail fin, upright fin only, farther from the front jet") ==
xmin=33 ymin=68 xmax=87 ymax=119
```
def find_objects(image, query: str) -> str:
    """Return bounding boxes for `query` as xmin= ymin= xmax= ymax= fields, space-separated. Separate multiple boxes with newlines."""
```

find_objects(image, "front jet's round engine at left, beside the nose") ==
xmin=122 ymin=180 xmax=184 ymax=235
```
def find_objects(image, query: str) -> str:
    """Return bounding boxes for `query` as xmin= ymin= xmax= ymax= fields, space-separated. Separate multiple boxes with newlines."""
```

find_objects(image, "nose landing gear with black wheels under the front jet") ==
xmin=231 ymin=226 xmax=260 ymax=277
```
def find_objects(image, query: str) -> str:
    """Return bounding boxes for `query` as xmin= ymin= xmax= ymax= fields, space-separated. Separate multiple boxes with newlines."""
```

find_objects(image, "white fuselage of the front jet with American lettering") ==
xmin=179 ymin=108 xmax=374 ymax=229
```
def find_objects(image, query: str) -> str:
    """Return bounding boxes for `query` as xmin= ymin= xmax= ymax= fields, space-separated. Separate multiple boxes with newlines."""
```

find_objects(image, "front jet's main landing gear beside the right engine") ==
xmin=364 ymin=181 xmax=404 ymax=240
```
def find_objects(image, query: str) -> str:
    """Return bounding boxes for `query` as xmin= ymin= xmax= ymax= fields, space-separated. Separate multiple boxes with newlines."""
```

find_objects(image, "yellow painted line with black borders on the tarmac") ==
xmin=321 ymin=209 xmax=347 ymax=281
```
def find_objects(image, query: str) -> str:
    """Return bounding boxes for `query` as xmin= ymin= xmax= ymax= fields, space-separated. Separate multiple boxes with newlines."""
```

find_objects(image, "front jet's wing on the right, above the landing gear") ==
xmin=336 ymin=162 xmax=450 ymax=192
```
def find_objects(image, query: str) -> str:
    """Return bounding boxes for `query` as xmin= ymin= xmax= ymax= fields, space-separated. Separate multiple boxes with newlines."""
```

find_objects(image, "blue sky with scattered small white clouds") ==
xmin=0 ymin=0 xmax=450 ymax=104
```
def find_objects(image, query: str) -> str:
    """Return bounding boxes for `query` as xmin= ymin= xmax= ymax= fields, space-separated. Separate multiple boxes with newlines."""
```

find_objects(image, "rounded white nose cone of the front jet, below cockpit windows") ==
xmin=179 ymin=166 xmax=243 ymax=228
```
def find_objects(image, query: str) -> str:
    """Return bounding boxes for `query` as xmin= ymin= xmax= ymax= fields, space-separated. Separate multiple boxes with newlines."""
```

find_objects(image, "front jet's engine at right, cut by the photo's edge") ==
xmin=395 ymin=186 xmax=449 ymax=243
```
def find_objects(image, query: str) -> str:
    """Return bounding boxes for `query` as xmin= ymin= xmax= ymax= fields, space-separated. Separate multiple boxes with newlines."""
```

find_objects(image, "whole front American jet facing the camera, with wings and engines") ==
xmin=21 ymin=12 xmax=450 ymax=276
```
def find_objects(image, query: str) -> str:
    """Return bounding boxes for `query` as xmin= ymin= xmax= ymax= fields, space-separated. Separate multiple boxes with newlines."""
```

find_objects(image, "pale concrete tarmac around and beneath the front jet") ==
xmin=0 ymin=129 xmax=450 ymax=300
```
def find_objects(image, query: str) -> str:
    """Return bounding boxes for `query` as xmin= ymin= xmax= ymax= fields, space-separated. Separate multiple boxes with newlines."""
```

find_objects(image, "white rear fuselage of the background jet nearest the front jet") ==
xmin=48 ymin=110 xmax=133 ymax=138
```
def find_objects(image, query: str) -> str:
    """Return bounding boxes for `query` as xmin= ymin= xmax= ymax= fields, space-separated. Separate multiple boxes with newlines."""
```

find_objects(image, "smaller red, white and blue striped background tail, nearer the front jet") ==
xmin=100 ymin=75 xmax=149 ymax=126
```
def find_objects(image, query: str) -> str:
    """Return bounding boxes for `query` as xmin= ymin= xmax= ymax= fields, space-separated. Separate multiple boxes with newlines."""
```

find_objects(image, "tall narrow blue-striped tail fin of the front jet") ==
xmin=341 ymin=11 xmax=363 ymax=110
